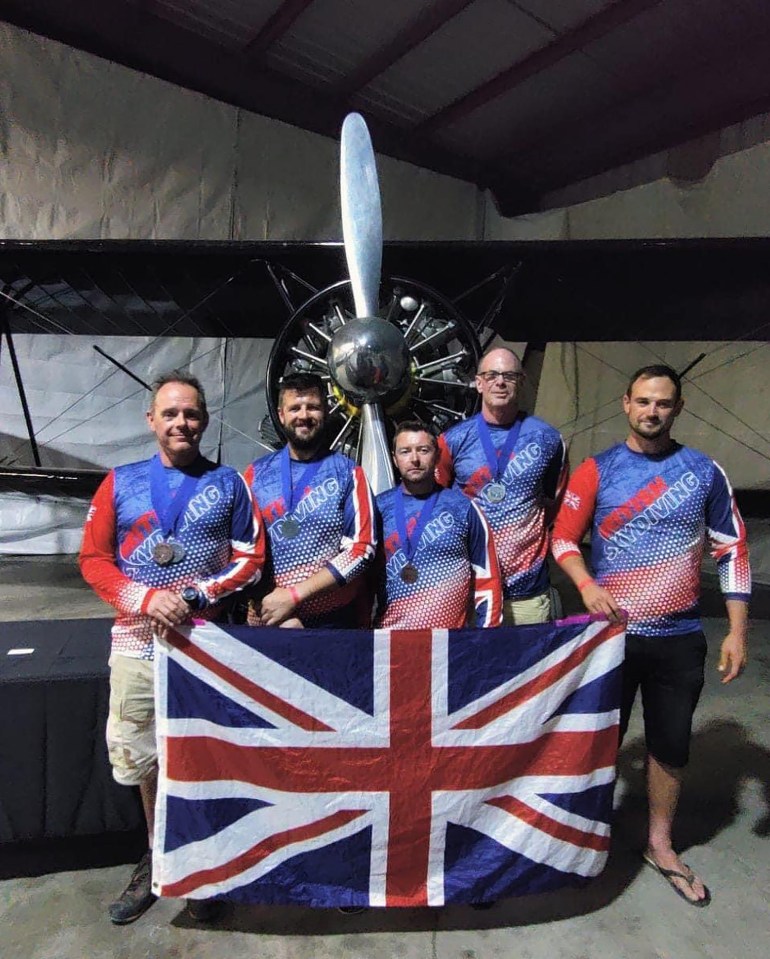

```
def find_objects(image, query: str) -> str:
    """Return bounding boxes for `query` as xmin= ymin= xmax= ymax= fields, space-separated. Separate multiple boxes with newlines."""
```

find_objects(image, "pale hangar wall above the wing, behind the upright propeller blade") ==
xmin=0 ymin=23 xmax=483 ymax=241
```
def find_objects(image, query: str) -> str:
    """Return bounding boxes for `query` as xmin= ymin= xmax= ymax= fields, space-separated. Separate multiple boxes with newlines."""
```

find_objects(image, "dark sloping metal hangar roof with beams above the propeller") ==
xmin=3 ymin=0 xmax=770 ymax=213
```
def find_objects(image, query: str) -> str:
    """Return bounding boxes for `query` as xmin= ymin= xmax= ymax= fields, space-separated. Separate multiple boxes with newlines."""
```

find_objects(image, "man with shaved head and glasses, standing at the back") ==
xmin=436 ymin=347 xmax=568 ymax=625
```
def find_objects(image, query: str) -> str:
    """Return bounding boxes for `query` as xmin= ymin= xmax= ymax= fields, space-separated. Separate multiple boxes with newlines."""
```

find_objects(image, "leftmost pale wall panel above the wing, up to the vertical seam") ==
xmin=0 ymin=23 xmax=236 ymax=239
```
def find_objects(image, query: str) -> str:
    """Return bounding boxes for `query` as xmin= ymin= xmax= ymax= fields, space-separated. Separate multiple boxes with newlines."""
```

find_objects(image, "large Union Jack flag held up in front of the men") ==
xmin=153 ymin=616 xmax=624 ymax=906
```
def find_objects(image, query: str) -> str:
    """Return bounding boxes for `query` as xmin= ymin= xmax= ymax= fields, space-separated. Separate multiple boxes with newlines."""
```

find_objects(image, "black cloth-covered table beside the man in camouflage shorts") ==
xmin=0 ymin=619 xmax=144 ymax=842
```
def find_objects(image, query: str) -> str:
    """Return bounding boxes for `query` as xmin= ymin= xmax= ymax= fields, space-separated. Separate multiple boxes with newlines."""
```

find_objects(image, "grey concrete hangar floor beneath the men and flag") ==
xmin=0 ymin=557 xmax=770 ymax=959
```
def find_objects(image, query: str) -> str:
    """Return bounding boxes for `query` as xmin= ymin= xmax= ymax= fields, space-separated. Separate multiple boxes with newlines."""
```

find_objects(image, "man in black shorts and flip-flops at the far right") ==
xmin=552 ymin=365 xmax=751 ymax=908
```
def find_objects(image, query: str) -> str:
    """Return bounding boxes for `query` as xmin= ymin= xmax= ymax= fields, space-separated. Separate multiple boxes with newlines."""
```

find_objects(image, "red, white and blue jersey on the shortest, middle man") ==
xmin=375 ymin=489 xmax=503 ymax=629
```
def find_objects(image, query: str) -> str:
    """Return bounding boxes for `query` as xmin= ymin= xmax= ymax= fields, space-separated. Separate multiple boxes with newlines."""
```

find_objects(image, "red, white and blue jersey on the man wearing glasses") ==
xmin=436 ymin=413 xmax=568 ymax=599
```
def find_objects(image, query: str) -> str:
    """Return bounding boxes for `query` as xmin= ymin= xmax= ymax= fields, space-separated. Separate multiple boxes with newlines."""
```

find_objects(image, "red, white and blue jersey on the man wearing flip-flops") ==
xmin=553 ymin=443 xmax=751 ymax=636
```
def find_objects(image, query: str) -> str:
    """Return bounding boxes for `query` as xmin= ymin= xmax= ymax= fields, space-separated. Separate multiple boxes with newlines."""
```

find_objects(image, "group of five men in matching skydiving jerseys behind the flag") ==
xmin=81 ymin=348 xmax=750 ymax=924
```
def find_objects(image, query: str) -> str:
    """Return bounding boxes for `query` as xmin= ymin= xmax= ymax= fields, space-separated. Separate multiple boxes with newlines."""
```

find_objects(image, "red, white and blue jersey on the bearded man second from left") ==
xmin=244 ymin=451 xmax=377 ymax=628
